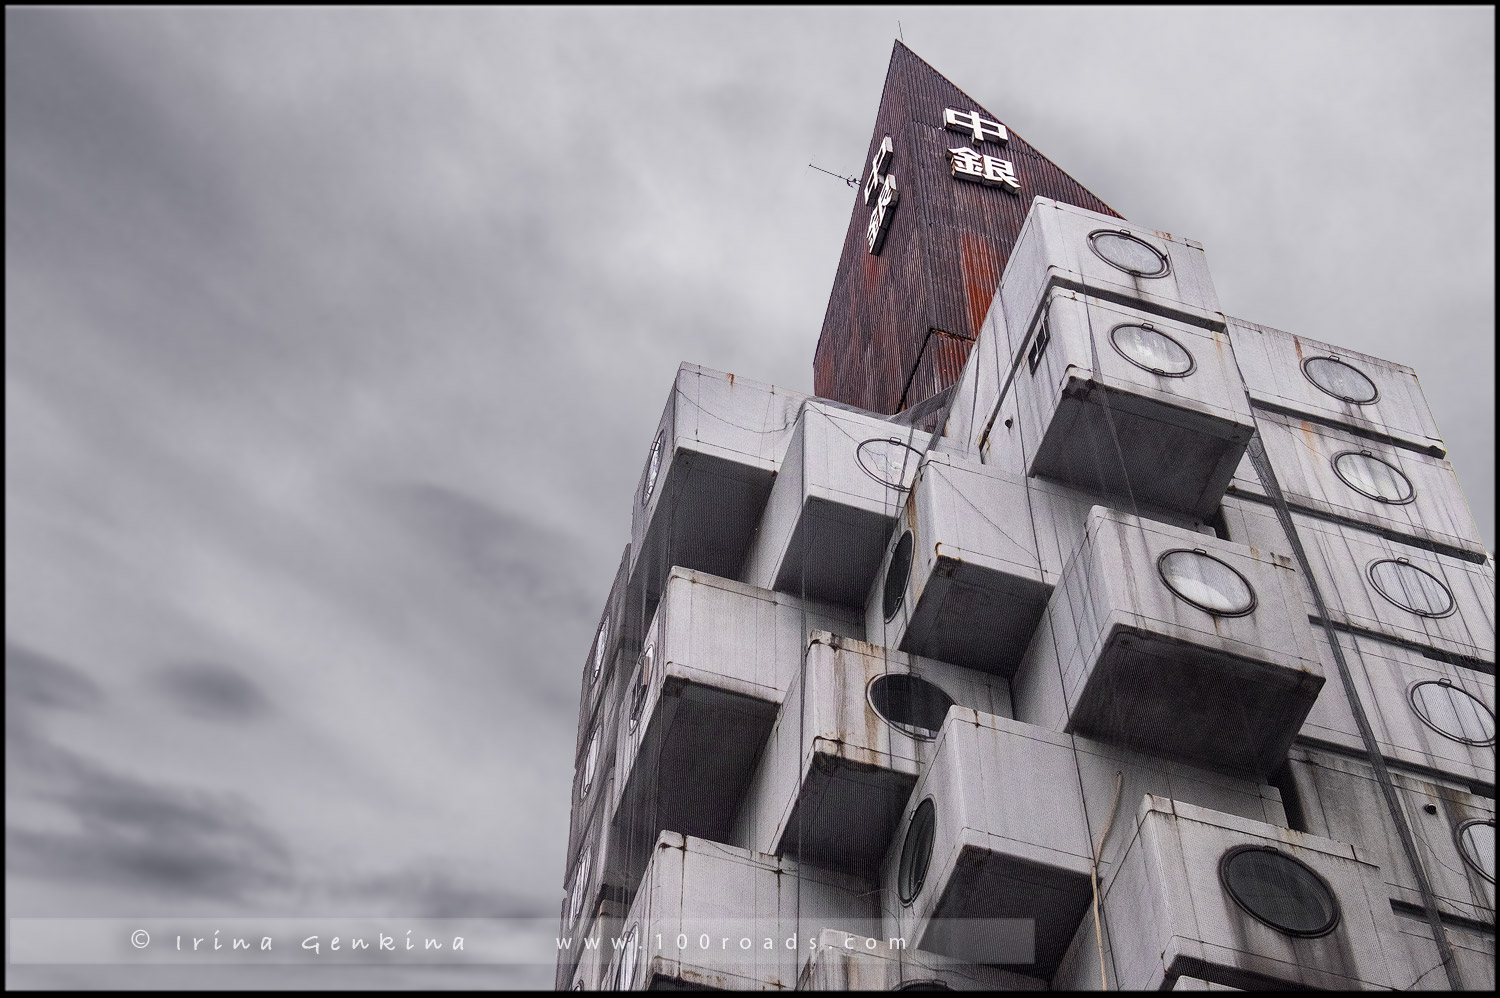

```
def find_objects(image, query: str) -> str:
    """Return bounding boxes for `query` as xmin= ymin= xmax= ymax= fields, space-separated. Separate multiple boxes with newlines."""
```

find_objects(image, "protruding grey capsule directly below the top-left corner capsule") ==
xmin=614 ymin=569 xmax=860 ymax=876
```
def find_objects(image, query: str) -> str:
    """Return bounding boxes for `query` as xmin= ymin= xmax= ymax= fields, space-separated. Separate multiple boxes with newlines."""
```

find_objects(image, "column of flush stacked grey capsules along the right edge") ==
xmin=1220 ymin=320 xmax=1496 ymax=989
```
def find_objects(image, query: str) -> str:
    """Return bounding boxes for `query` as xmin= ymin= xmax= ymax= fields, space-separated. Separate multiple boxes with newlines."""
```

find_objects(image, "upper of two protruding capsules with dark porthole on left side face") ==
xmin=864 ymin=453 xmax=1053 ymax=677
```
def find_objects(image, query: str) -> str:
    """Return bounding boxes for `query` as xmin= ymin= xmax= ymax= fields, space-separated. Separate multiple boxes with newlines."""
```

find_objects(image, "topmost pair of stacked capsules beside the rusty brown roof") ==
xmin=977 ymin=198 xmax=1254 ymax=516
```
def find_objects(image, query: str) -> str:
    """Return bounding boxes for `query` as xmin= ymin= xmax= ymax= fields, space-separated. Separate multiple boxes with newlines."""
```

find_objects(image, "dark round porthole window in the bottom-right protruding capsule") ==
xmin=1220 ymin=845 xmax=1338 ymax=936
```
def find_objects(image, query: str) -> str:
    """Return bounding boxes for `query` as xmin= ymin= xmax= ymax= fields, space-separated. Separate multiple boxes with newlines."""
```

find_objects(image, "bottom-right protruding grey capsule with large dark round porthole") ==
xmin=1104 ymin=795 xmax=1401 ymax=990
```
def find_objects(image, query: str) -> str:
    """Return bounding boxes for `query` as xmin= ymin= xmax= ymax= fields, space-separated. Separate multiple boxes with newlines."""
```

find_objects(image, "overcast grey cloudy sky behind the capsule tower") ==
xmin=6 ymin=8 xmax=1496 ymax=986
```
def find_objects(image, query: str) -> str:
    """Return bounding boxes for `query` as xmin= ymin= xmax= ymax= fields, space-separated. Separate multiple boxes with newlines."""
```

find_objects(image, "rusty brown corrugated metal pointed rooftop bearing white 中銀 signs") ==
xmin=813 ymin=42 xmax=1118 ymax=413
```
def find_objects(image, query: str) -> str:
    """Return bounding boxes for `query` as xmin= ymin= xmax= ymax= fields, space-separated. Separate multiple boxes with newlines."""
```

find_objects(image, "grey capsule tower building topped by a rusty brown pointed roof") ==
xmin=557 ymin=42 xmax=1496 ymax=990
